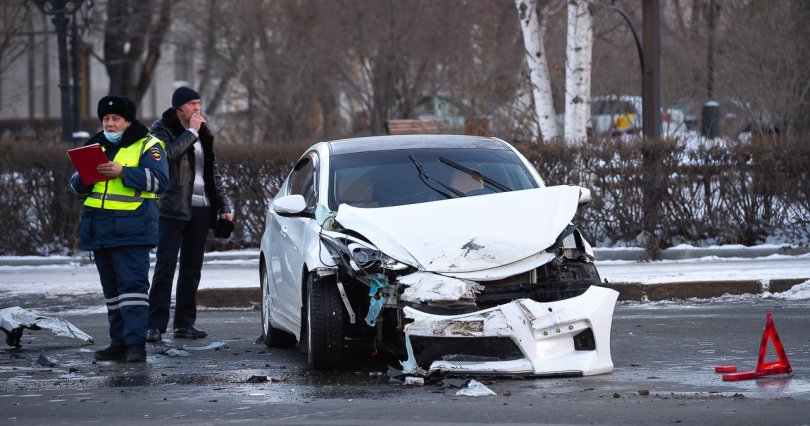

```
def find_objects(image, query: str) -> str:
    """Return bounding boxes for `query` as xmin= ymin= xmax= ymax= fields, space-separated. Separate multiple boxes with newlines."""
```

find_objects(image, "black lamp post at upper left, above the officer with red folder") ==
xmin=32 ymin=0 xmax=82 ymax=141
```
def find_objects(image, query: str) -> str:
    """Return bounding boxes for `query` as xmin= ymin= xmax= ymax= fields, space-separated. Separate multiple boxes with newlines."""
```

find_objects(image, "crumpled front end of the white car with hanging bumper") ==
xmin=321 ymin=188 xmax=618 ymax=376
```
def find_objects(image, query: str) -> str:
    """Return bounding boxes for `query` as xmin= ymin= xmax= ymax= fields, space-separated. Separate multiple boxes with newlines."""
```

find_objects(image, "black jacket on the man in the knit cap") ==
xmin=151 ymin=108 xmax=233 ymax=227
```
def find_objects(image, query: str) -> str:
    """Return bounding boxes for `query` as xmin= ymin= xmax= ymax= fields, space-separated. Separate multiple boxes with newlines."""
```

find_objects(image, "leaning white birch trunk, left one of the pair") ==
xmin=515 ymin=0 xmax=560 ymax=140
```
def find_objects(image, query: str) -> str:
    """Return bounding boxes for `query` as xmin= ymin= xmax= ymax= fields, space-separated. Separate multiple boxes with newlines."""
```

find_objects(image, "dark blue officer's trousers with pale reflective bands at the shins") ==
xmin=93 ymin=245 xmax=150 ymax=346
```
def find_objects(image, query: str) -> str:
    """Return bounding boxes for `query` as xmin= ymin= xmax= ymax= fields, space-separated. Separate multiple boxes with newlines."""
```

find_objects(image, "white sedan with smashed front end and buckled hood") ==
xmin=260 ymin=135 xmax=618 ymax=376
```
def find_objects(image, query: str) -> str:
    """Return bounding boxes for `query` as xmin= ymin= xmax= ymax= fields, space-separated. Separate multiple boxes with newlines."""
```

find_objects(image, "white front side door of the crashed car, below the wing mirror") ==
xmin=270 ymin=152 xmax=318 ymax=326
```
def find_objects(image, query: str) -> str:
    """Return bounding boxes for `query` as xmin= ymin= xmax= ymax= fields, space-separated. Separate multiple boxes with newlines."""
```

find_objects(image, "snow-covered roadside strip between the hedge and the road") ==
xmin=0 ymin=246 xmax=810 ymax=308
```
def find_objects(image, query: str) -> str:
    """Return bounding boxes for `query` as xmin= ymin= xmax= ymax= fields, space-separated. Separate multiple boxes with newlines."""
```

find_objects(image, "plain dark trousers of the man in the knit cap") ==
xmin=149 ymin=207 xmax=209 ymax=333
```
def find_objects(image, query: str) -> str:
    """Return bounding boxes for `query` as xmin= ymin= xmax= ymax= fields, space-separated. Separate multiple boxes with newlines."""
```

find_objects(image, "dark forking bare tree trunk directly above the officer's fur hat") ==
xmin=103 ymin=0 xmax=173 ymax=103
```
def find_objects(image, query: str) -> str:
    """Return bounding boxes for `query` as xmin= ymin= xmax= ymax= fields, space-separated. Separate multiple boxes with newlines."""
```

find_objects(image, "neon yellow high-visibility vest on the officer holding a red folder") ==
xmin=84 ymin=135 xmax=163 ymax=210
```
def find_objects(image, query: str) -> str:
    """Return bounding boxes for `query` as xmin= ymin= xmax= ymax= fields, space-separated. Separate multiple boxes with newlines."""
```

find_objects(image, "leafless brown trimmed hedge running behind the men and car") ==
xmin=0 ymin=135 xmax=810 ymax=257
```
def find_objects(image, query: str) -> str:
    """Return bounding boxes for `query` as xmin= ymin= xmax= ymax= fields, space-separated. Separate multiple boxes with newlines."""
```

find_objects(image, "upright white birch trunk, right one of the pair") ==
xmin=565 ymin=0 xmax=593 ymax=144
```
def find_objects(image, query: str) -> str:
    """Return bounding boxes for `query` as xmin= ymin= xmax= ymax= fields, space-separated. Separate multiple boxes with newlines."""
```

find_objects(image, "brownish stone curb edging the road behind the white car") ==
xmin=197 ymin=278 xmax=810 ymax=310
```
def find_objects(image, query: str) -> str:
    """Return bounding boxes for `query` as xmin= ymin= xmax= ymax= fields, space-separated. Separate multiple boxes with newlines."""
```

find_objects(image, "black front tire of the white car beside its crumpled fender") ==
xmin=306 ymin=275 xmax=345 ymax=371
